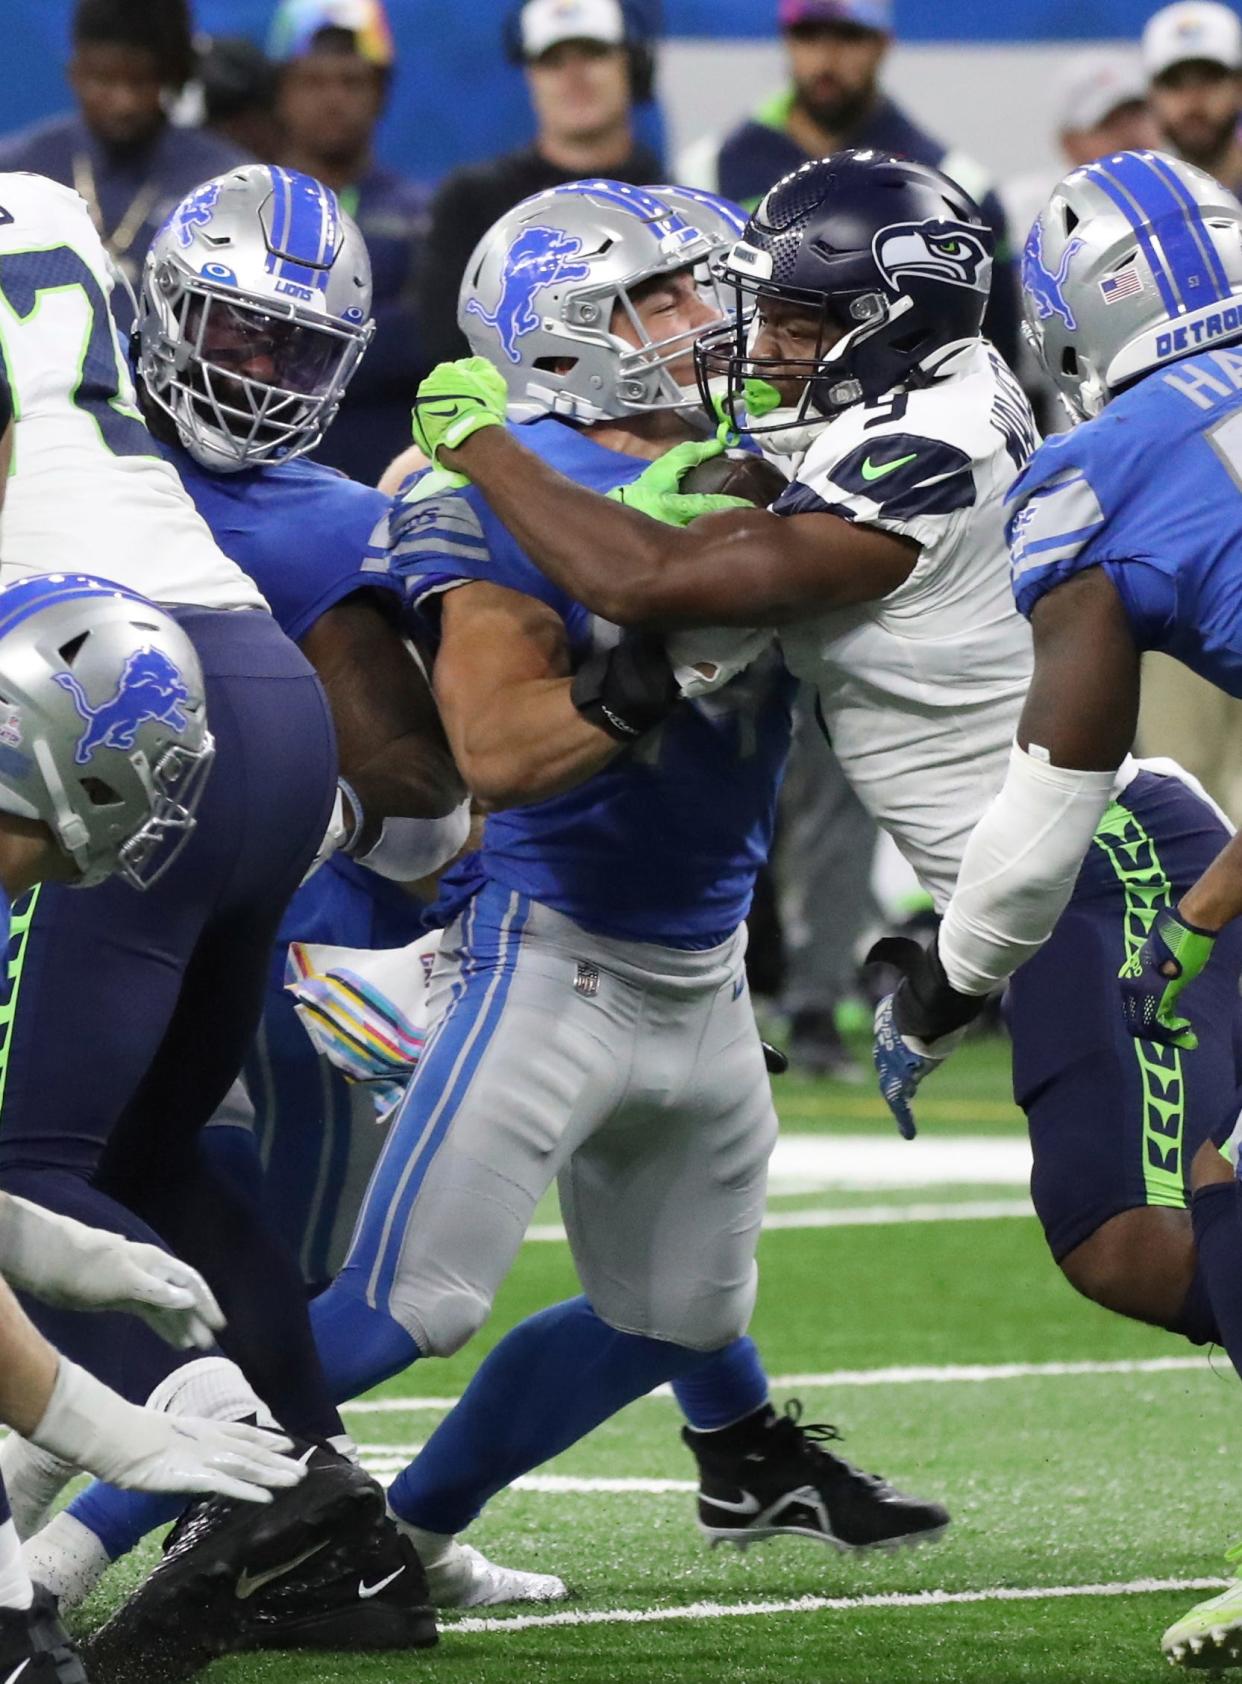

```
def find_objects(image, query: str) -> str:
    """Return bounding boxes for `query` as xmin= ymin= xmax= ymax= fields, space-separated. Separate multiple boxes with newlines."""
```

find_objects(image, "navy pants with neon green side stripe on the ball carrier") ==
xmin=1006 ymin=771 xmax=1242 ymax=1261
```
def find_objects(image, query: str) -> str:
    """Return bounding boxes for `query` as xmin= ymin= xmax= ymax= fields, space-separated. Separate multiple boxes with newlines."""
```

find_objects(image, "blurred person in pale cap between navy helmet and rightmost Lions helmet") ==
xmin=1001 ymin=49 xmax=1160 ymax=433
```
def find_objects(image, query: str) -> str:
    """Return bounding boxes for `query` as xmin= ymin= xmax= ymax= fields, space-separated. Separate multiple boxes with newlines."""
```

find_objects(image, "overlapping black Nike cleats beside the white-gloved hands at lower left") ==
xmin=81 ymin=1445 xmax=438 ymax=1684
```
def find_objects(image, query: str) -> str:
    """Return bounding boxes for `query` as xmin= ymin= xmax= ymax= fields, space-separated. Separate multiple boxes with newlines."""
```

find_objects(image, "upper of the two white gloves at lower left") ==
xmin=0 ymin=1194 xmax=224 ymax=1351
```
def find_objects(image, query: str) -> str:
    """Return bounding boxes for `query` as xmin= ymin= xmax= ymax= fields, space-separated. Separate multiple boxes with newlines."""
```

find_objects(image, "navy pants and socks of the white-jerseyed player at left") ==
xmin=0 ymin=610 xmax=337 ymax=1435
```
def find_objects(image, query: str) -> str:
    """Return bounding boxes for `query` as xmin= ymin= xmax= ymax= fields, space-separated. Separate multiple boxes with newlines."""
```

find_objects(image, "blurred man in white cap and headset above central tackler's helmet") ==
xmin=419 ymin=0 xmax=665 ymax=362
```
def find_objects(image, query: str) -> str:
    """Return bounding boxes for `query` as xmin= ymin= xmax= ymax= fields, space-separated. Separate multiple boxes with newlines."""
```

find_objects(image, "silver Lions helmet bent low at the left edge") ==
xmin=0 ymin=573 xmax=214 ymax=889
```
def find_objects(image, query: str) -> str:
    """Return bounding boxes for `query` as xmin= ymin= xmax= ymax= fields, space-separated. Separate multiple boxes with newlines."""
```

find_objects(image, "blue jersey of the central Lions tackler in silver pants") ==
xmin=392 ymin=419 xmax=793 ymax=948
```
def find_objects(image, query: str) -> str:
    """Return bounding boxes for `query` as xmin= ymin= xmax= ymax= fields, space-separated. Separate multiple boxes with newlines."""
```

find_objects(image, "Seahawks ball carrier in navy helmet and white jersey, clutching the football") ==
xmin=408 ymin=152 xmax=1237 ymax=1515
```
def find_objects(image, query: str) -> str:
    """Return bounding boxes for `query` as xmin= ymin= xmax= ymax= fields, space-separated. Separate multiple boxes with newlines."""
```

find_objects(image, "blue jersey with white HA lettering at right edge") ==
xmin=1008 ymin=349 xmax=1242 ymax=697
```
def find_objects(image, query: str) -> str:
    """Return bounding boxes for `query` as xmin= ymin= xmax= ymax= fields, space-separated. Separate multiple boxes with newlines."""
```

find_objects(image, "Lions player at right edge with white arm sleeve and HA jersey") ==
xmin=861 ymin=152 xmax=1242 ymax=1665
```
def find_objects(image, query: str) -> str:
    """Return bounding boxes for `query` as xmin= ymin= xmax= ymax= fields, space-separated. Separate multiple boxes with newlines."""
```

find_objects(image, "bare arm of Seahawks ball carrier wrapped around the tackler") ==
xmin=438 ymin=426 xmax=919 ymax=630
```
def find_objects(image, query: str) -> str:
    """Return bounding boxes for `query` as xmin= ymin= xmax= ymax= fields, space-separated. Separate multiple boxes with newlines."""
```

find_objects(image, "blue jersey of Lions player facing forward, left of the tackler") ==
xmin=163 ymin=445 xmax=397 ymax=643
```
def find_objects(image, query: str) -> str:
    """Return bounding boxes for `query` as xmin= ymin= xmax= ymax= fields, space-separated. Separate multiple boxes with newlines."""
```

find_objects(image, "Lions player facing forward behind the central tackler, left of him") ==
xmin=10 ymin=165 xmax=504 ymax=1643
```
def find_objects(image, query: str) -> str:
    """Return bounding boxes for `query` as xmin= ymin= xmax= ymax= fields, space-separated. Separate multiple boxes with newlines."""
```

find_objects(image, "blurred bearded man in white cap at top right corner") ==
xmin=1143 ymin=0 xmax=1242 ymax=192
